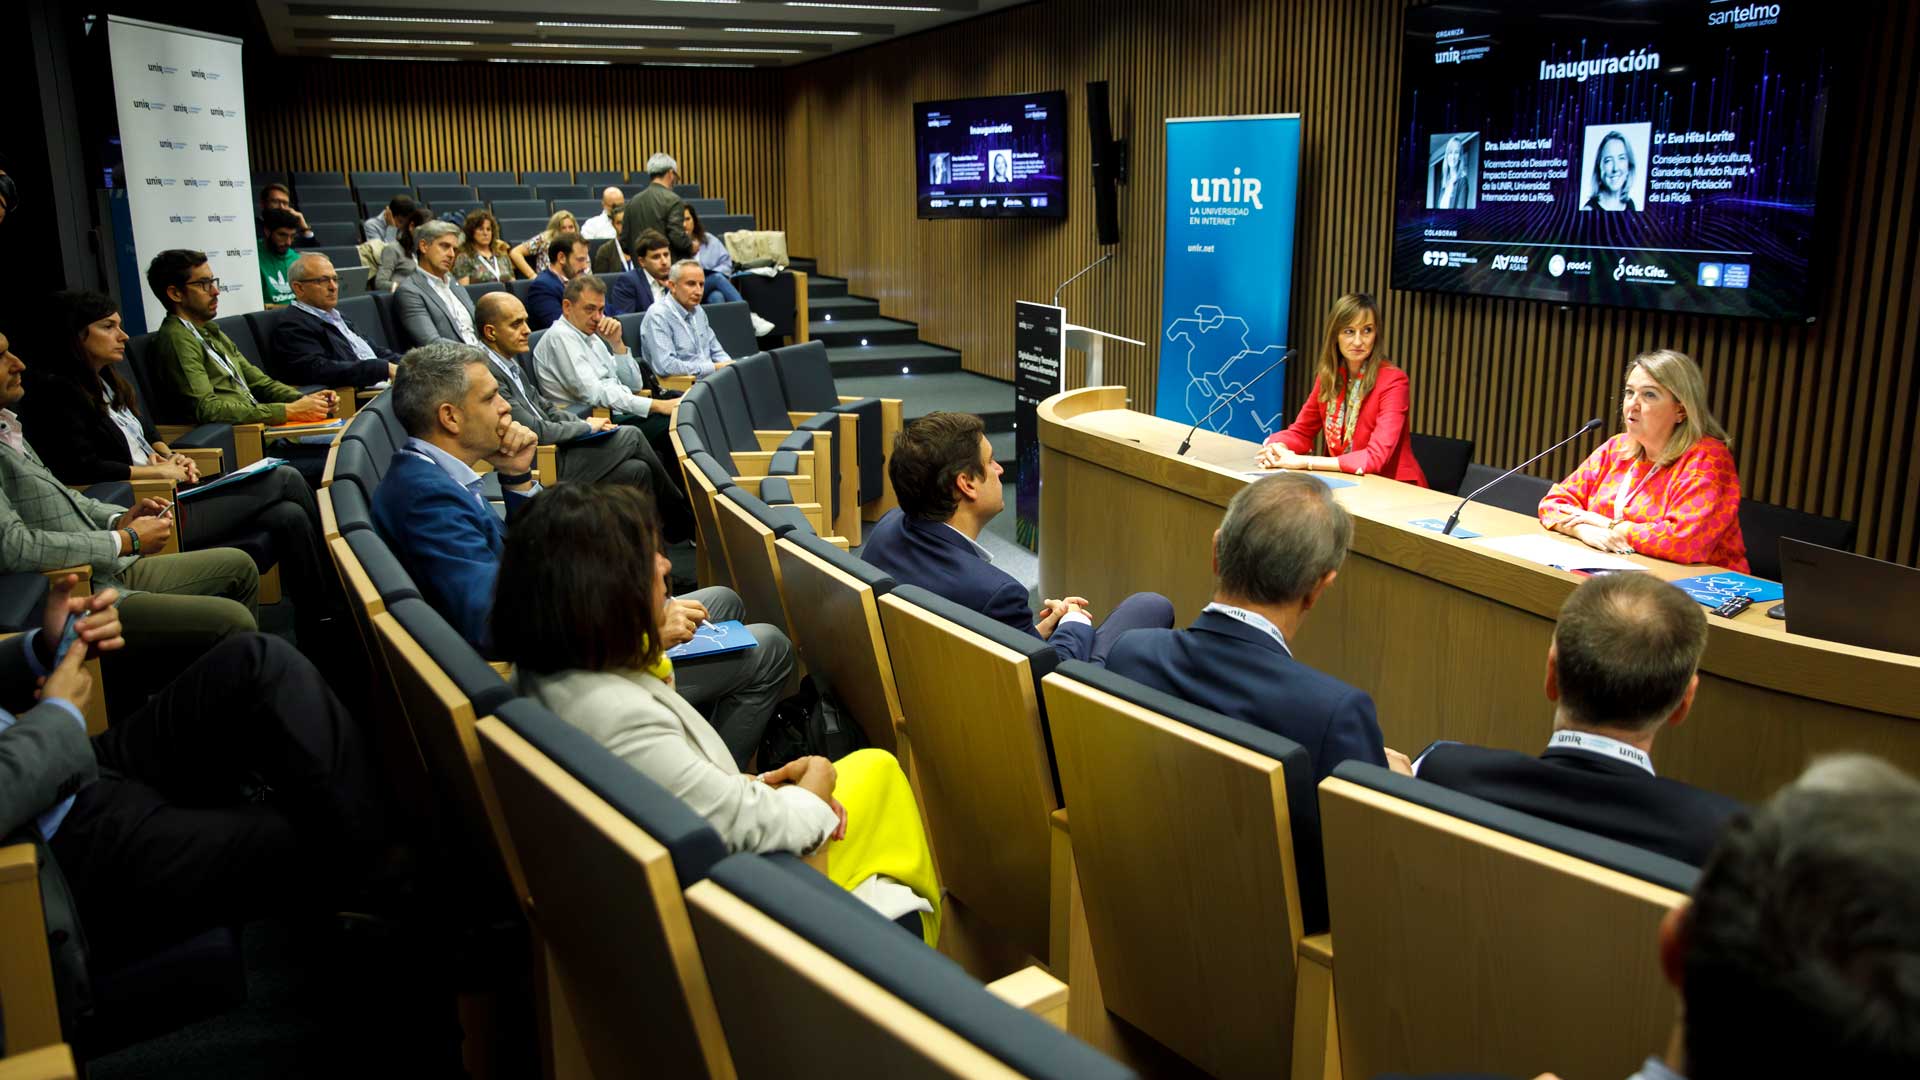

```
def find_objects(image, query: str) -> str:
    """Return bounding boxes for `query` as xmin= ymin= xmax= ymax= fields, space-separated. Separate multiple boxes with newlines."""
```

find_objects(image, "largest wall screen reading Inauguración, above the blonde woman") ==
xmin=1394 ymin=0 xmax=1849 ymax=319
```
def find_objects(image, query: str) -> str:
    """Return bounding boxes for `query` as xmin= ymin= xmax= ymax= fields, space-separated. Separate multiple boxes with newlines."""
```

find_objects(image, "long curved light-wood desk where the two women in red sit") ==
xmin=1039 ymin=386 xmax=1920 ymax=801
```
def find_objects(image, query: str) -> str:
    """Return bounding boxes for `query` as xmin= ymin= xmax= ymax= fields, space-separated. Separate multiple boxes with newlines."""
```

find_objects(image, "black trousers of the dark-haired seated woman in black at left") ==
xmin=179 ymin=455 xmax=346 ymax=648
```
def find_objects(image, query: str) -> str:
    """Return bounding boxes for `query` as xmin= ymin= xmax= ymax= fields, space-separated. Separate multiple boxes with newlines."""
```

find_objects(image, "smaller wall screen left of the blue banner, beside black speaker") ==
xmin=914 ymin=90 xmax=1068 ymax=217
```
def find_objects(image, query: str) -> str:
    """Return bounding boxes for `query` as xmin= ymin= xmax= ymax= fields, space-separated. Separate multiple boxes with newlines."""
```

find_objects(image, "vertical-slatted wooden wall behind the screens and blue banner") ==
xmin=783 ymin=0 xmax=1920 ymax=565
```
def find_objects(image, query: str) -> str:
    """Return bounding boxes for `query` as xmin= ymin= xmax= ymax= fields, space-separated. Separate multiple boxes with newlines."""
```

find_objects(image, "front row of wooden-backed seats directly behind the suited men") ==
xmin=656 ymin=402 xmax=1695 ymax=1076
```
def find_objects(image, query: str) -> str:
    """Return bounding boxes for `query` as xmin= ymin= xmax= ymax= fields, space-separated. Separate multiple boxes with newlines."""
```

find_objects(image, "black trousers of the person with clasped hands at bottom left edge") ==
xmin=50 ymin=634 xmax=380 ymax=969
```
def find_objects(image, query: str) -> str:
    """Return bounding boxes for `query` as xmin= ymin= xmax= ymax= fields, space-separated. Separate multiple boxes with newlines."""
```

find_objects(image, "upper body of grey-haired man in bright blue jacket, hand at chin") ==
xmin=372 ymin=342 xmax=540 ymax=653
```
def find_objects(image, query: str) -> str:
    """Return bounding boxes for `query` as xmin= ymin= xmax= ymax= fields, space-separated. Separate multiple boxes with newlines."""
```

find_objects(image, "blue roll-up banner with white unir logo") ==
xmin=1154 ymin=113 xmax=1300 ymax=442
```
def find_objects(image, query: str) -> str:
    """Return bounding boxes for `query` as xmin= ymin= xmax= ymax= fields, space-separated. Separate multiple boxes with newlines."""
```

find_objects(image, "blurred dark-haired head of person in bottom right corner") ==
xmin=1636 ymin=753 xmax=1920 ymax=1080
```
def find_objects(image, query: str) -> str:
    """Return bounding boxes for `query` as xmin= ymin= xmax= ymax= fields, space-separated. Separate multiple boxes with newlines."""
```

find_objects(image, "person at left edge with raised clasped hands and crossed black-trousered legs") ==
xmin=0 ymin=577 xmax=380 ymax=970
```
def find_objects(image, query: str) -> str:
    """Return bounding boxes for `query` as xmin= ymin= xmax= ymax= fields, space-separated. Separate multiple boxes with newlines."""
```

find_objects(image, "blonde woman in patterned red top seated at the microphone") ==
xmin=1540 ymin=350 xmax=1747 ymax=573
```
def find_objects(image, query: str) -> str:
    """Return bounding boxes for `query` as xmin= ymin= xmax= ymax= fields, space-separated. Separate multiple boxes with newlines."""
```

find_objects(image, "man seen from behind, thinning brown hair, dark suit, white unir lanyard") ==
xmin=1413 ymin=575 xmax=1740 ymax=867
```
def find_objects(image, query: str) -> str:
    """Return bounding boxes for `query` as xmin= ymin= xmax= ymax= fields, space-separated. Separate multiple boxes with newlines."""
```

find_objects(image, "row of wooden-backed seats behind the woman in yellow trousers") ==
xmin=321 ymin=378 xmax=1129 ymax=1078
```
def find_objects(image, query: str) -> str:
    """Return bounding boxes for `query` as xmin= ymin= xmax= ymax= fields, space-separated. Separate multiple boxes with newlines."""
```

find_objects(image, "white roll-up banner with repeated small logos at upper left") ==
xmin=108 ymin=15 xmax=261 ymax=331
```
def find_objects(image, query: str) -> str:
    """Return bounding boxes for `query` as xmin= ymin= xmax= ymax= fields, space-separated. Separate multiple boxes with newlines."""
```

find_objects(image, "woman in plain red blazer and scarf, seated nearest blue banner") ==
xmin=1254 ymin=292 xmax=1427 ymax=488
